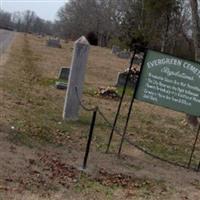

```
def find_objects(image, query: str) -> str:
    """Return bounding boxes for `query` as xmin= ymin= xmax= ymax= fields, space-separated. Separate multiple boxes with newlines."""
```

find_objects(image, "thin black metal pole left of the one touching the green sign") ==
xmin=106 ymin=49 xmax=136 ymax=153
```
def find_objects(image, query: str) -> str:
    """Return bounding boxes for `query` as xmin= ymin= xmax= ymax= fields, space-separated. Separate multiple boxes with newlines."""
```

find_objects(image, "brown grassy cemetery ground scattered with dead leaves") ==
xmin=0 ymin=34 xmax=200 ymax=200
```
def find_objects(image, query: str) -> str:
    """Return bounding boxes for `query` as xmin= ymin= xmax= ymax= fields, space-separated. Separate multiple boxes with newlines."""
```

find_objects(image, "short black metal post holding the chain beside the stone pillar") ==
xmin=83 ymin=109 xmax=97 ymax=169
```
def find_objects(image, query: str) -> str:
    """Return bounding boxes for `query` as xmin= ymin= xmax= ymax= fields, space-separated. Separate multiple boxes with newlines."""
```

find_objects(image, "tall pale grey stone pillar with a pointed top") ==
xmin=63 ymin=36 xmax=90 ymax=120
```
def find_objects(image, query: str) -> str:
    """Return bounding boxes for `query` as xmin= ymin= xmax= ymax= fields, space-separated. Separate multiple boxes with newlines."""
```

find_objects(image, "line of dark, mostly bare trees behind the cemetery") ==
xmin=0 ymin=0 xmax=200 ymax=58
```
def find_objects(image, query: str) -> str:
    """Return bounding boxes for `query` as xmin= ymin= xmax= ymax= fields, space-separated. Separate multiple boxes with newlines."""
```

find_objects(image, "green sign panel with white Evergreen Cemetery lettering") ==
xmin=136 ymin=50 xmax=200 ymax=116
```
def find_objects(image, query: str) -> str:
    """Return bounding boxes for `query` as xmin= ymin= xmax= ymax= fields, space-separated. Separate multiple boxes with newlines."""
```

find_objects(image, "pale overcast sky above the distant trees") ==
xmin=0 ymin=0 xmax=67 ymax=21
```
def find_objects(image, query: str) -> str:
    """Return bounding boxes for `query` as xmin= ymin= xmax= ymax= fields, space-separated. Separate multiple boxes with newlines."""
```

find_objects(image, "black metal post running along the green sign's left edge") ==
xmin=118 ymin=49 xmax=147 ymax=156
